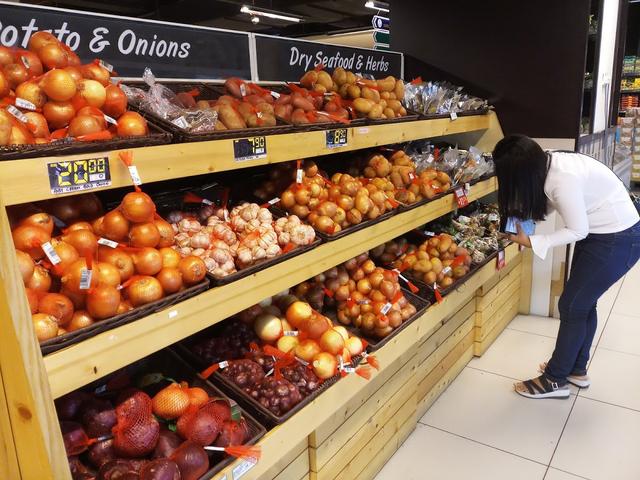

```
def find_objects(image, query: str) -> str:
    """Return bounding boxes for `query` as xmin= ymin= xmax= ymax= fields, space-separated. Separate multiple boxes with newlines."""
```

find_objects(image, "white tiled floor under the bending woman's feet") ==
xmin=376 ymin=265 xmax=640 ymax=480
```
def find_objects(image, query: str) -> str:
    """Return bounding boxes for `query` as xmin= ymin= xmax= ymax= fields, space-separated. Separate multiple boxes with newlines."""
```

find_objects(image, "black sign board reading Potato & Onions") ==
xmin=0 ymin=3 xmax=251 ymax=79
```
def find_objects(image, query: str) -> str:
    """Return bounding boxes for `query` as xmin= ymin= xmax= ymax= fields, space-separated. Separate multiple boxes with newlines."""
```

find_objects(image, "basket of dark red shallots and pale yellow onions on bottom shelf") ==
xmin=188 ymin=294 xmax=368 ymax=416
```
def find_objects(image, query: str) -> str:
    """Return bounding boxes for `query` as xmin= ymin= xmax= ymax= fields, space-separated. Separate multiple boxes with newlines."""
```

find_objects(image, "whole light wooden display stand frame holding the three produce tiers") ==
xmin=0 ymin=113 xmax=526 ymax=480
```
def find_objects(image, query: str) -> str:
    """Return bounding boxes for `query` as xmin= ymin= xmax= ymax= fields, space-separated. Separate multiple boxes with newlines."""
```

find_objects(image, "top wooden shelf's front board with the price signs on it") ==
xmin=0 ymin=114 xmax=494 ymax=205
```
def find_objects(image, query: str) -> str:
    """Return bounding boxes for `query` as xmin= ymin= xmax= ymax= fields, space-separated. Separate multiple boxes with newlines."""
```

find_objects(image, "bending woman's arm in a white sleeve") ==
xmin=529 ymin=174 xmax=589 ymax=259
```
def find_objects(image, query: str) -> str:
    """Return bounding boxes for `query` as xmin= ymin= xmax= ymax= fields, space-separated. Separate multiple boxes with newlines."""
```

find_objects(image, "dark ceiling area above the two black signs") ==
xmin=23 ymin=0 xmax=384 ymax=37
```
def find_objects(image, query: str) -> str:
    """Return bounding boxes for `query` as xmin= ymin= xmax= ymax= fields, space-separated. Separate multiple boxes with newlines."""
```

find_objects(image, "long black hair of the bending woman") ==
xmin=493 ymin=135 xmax=550 ymax=224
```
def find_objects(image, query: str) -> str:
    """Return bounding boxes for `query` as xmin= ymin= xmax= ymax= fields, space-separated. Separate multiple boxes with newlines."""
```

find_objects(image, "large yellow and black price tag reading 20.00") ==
xmin=47 ymin=157 xmax=111 ymax=195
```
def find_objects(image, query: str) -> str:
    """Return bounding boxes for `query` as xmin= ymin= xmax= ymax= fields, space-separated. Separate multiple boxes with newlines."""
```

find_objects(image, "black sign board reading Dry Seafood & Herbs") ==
xmin=255 ymin=35 xmax=402 ymax=82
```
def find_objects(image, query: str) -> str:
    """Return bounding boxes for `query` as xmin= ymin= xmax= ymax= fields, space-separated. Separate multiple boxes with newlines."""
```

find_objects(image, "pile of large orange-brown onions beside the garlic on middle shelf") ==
xmin=10 ymin=191 xmax=206 ymax=342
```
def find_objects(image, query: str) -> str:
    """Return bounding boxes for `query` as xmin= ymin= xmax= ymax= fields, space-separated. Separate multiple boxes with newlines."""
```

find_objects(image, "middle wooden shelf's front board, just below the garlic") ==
xmin=44 ymin=176 xmax=497 ymax=398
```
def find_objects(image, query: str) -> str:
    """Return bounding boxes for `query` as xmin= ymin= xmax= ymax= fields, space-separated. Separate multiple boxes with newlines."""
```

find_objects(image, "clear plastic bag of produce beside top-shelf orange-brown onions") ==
xmin=122 ymin=68 xmax=218 ymax=133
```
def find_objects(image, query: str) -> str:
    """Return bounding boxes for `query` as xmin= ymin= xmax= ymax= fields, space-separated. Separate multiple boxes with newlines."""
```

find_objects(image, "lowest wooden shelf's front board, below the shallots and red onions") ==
xmin=214 ymin=244 xmax=520 ymax=480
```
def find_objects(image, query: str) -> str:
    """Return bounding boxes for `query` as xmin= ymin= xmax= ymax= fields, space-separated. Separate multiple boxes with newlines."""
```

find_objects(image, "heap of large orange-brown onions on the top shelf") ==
xmin=0 ymin=31 xmax=149 ymax=145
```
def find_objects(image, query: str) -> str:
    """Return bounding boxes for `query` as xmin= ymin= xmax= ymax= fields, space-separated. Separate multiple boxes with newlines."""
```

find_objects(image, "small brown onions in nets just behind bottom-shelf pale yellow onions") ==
xmin=295 ymin=253 xmax=416 ymax=338
